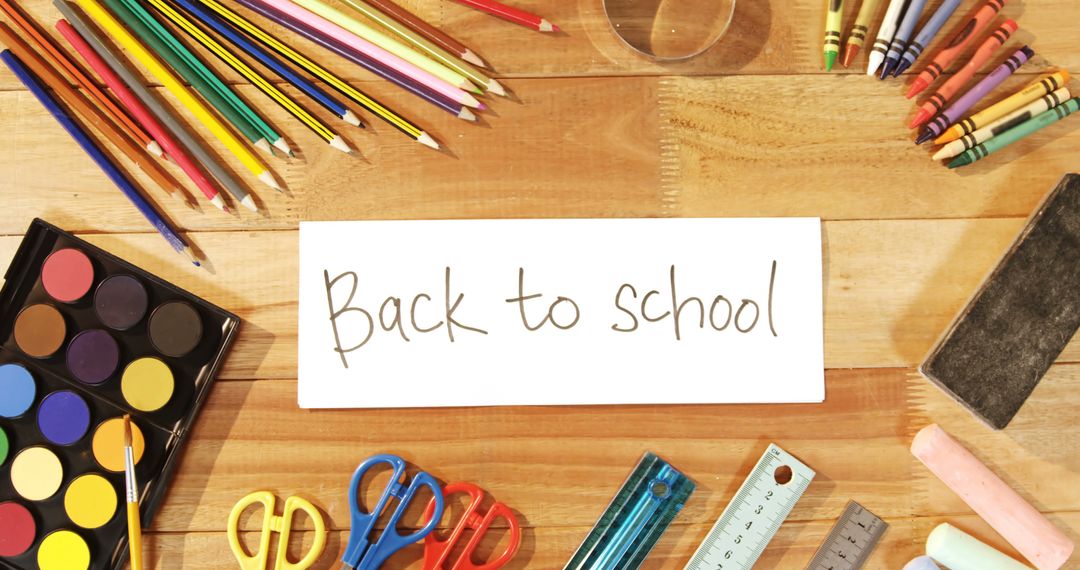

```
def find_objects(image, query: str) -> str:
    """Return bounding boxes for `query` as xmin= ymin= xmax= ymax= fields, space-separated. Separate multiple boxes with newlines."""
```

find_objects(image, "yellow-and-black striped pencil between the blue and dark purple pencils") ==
xmin=190 ymin=0 xmax=438 ymax=149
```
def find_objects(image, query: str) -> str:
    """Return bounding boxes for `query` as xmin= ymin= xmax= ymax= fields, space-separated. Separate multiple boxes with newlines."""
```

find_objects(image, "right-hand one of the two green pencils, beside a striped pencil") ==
xmin=113 ymin=0 xmax=292 ymax=155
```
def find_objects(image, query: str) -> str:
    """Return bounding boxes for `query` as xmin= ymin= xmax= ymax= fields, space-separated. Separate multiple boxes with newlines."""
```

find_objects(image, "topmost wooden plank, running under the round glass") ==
xmin=0 ymin=0 xmax=1080 ymax=85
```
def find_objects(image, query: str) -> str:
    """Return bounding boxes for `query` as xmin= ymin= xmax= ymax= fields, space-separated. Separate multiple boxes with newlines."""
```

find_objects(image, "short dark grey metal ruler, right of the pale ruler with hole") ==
xmin=807 ymin=501 xmax=889 ymax=570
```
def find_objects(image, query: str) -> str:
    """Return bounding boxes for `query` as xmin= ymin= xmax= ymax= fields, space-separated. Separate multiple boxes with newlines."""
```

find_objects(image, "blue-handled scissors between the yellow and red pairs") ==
xmin=341 ymin=453 xmax=443 ymax=570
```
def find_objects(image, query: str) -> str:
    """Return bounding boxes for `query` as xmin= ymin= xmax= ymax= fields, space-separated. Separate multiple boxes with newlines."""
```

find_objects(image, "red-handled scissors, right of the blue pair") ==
xmin=423 ymin=483 xmax=522 ymax=570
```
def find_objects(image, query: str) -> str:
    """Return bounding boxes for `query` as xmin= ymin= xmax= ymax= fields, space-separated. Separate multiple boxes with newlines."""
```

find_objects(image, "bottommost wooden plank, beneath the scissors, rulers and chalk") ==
xmin=144 ymin=512 xmax=1080 ymax=570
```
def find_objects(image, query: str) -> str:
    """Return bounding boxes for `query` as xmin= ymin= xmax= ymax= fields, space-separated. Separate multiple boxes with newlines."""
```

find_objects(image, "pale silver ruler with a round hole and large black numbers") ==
xmin=686 ymin=444 xmax=814 ymax=570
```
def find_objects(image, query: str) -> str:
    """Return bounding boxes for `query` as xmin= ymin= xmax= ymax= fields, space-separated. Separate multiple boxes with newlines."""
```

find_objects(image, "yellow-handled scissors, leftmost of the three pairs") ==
xmin=229 ymin=491 xmax=326 ymax=570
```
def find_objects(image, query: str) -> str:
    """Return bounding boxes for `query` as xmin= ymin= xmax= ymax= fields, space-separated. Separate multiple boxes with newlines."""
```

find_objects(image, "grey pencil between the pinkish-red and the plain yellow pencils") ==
xmin=53 ymin=0 xmax=254 ymax=212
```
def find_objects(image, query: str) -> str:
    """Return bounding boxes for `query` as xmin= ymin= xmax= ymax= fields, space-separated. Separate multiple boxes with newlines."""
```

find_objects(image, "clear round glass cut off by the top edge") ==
xmin=604 ymin=0 xmax=735 ymax=62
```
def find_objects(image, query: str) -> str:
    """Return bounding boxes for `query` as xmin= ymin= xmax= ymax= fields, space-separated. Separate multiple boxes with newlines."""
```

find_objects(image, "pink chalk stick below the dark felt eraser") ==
xmin=912 ymin=423 xmax=1074 ymax=570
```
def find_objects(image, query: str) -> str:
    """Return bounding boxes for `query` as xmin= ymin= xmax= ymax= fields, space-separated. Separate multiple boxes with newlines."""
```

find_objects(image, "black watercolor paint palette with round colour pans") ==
xmin=0 ymin=219 xmax=240 ymax=570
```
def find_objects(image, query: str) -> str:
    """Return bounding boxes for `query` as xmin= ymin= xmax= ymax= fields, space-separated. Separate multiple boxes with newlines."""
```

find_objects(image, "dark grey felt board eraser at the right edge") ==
xmin=919 ymin=174 xmax=1080 ymax=430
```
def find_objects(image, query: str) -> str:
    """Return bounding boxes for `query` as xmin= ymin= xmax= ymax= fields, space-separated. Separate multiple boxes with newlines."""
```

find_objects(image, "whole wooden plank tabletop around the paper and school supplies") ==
xmin=0 ymin=0 xmax=1080 ymax=569
